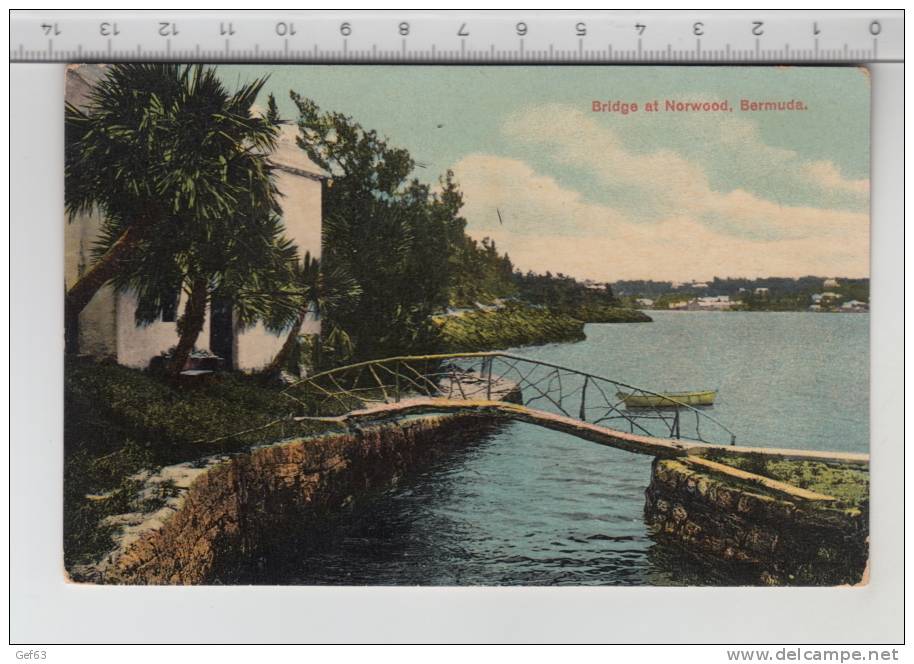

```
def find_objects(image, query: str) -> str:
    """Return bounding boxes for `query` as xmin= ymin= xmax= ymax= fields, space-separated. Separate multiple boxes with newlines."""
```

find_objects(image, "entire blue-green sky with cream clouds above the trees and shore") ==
xmin=219 ymin=65 xmax=870 ymax=281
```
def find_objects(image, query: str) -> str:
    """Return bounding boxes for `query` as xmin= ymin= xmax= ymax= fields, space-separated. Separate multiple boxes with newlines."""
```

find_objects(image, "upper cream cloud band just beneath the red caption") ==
xmin=503 ymin=104 xmax=869 ymax=214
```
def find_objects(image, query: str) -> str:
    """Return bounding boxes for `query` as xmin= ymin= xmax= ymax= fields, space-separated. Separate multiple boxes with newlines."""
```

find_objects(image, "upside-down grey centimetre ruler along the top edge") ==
xmin=10 ymin=10 xmax=904 ymax=64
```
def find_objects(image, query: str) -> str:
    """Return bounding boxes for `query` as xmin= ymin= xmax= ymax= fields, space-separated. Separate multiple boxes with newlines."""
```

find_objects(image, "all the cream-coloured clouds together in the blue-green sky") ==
xmin=454 ymin=104 xmax=869 ymax=280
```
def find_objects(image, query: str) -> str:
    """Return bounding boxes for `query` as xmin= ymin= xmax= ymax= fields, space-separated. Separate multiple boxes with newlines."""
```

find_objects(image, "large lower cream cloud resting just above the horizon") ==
xmin=454 ymin=154 xmax=869 ymax=280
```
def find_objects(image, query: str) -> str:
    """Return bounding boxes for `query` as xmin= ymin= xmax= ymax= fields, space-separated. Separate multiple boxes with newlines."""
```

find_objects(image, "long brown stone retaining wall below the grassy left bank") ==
xmin=84 ymin=416 xmax=495 ymax=584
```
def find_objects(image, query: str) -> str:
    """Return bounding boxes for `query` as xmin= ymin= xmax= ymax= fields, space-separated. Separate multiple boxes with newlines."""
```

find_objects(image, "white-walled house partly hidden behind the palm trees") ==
xmin=64 ymin=65 xmax=326 ymax=371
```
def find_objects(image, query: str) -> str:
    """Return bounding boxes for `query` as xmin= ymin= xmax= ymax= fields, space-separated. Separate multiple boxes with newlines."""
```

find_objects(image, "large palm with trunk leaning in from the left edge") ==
xmin=65 ymin=64 xmax=279 ymax=352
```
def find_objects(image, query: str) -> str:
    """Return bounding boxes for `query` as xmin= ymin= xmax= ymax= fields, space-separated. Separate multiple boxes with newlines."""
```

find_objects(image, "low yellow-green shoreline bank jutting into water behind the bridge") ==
xmin=435 ymin=306 xmax=584 ymax=353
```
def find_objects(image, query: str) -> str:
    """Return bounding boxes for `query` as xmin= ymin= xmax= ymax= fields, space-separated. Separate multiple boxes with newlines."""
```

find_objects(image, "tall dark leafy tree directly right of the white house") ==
xmin=290 ymin=92 xmax=449 ymax=359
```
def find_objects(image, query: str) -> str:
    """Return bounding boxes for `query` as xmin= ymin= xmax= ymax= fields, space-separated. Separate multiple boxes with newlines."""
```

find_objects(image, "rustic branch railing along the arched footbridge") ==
xmin=284 ymin=352 xmax=736 ymax=445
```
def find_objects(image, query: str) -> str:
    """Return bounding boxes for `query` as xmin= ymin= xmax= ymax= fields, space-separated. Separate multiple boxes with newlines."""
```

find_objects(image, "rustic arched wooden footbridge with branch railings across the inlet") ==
xmin=283 ymin=352 xmax=869 ymax=500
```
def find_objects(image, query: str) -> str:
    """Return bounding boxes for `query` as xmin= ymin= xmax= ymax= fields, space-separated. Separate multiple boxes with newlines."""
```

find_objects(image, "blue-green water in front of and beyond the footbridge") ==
xmin=255 ymin=312 xmax=869 ymax=585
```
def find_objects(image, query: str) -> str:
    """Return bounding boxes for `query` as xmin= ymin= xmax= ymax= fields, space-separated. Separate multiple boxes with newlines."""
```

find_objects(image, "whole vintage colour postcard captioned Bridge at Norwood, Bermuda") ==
xmin=61 ymin=64 xmax=870 ymax=586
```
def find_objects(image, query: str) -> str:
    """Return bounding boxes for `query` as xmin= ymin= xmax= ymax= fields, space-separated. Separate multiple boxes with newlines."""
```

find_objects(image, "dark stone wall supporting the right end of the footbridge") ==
xmin=645 ymin=459 xmax=868 ymax=585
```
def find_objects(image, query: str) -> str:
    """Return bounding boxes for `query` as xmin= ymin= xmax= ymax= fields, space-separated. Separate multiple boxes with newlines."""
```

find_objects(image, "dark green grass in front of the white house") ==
xmin=64 ymin=358 xmax=332 ymax=566
